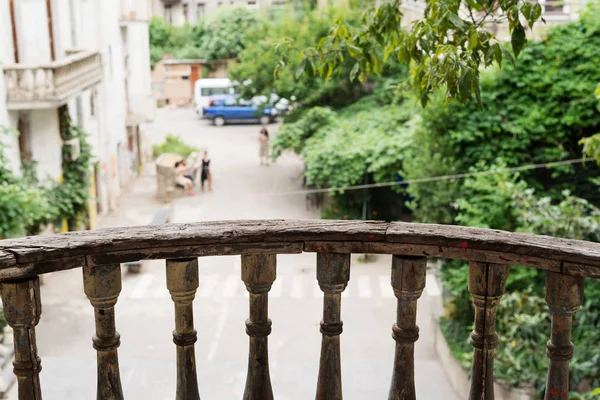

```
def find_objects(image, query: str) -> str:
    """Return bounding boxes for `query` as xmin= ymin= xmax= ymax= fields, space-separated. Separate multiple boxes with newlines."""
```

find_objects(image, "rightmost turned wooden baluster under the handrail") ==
xmin=544 ymin=271 xmax=583 ymax=400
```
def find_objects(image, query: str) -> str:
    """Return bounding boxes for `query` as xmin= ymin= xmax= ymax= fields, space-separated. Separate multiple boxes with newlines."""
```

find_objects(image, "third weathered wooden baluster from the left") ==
xmin=167 ymin=258 xmax=200 ymax=400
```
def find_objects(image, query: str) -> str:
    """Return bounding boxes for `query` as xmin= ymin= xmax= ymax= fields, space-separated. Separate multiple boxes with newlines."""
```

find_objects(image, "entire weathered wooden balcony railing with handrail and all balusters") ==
xmin=0 ymin=220 xmax=600 ymax=400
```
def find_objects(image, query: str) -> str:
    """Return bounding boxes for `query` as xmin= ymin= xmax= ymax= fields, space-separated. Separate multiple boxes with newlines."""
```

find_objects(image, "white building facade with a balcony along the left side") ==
xmin=0 ymin=0 xmax=154 ymax=222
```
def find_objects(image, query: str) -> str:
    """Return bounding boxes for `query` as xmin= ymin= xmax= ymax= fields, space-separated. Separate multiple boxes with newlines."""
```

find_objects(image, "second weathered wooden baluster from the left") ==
xmin=83 ymin=264 xmax=123 ymax=400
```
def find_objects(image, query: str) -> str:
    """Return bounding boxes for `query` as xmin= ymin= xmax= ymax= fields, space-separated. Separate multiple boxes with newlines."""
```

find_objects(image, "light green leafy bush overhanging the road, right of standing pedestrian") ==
xmin=273 ymin=83 xmax=417 ymax=188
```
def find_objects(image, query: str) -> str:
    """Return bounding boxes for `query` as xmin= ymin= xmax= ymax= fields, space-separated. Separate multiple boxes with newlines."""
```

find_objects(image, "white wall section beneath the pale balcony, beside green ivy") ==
xmin=29 ymin=108 xmax=62 ymax=180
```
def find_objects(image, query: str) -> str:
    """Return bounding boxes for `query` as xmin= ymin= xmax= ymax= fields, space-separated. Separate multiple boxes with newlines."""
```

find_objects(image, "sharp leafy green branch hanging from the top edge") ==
xmin=281 ymin=0 xmax=542 ymax=104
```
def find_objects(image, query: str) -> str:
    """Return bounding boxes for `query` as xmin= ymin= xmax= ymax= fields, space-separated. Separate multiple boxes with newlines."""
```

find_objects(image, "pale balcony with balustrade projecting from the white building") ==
xmin=4 ymin=50 xmax=102 ymax=110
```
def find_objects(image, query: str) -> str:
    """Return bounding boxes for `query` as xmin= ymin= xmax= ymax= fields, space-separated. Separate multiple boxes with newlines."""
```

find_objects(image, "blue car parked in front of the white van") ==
xmin=202 ymin=95 xmax=279 ymax=126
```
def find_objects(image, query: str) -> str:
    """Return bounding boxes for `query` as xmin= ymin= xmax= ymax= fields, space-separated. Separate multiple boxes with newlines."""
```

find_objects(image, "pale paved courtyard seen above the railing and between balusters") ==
xmin=11 ymin=110 xmax=455 ymax=400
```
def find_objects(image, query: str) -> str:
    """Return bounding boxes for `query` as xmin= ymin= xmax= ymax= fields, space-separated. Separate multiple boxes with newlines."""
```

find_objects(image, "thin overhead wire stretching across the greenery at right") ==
xmin=265 ymin=158 xmax=590 ymax=196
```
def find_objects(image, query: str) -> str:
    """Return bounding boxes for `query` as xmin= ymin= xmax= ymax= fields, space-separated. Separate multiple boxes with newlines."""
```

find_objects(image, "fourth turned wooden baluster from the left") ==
xmin=242 ymin=254 xmax=276 ymax=400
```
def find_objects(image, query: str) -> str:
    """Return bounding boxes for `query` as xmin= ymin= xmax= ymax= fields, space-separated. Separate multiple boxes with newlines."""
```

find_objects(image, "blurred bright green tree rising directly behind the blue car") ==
xmin=230 ymin=5 xmax=367 ymax=112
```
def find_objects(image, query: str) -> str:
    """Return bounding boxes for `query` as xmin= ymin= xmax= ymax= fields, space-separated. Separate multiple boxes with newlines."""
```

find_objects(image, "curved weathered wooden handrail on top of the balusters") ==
xmin=0 ymin=220 xmax=600 ymax=280
